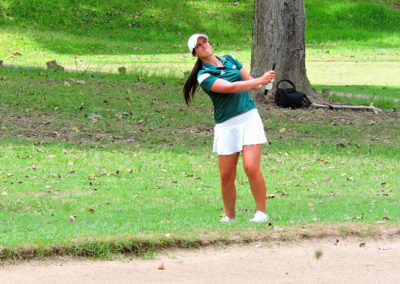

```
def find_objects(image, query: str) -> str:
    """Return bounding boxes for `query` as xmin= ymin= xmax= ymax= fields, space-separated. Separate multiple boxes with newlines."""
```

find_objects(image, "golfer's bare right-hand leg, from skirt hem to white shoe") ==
xmin=242 ymin=144 xmax=267 ymax=213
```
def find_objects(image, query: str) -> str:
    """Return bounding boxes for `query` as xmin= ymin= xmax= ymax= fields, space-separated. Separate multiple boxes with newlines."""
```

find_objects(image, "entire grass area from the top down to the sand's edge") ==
xmin=0 ymin=0 xmax=400 ymax=259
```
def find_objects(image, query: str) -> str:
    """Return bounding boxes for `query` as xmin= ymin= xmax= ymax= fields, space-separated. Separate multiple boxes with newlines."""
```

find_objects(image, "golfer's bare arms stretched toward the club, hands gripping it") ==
xmin=211 ymin=68 xmax=275 ymax=94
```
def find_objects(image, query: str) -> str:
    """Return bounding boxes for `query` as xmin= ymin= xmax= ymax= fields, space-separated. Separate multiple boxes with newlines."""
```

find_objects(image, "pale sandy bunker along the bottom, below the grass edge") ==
xmin=0 ymin=238 xmax=400 ymax=284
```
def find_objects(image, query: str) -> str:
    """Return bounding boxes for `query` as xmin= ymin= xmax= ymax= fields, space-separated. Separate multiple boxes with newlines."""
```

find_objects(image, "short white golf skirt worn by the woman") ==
xmin=213 ymin=109 xmax=267 ymax=155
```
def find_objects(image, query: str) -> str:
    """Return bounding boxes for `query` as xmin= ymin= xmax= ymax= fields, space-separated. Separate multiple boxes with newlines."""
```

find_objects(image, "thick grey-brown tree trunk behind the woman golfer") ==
xmin=251 ymin=0 xmax=317 ymax=101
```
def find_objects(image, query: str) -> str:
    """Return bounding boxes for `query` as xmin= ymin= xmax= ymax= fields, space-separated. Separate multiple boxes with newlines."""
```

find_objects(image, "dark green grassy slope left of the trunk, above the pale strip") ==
xmin=0 ymin=0 xmax=252 ymax=55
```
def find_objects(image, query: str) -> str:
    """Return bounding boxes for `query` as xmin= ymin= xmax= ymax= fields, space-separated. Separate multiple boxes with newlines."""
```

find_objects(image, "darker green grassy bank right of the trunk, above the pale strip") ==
xmin=305 ymin=0 xmax=400 ymax=48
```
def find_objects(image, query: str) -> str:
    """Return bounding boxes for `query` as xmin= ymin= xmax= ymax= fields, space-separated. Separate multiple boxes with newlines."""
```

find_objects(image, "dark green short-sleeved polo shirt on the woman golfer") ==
xmin=197 ymin=55 xmax=256 ymax=123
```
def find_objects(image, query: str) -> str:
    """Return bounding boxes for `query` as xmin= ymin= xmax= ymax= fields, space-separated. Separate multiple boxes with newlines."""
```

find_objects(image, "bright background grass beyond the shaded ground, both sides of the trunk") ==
xmin=0 ymin=0 xmax=400 ymax=109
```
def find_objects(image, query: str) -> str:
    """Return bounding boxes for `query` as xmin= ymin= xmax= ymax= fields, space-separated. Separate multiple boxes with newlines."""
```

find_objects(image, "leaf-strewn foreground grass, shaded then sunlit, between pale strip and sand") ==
xmin=0 ymin=69 xmax=400 ymax=258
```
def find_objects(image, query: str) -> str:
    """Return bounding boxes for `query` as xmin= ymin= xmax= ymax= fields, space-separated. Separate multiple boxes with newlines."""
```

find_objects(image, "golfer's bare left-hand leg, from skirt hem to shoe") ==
xmin=218 ymin=153 xmax=241 ymax=219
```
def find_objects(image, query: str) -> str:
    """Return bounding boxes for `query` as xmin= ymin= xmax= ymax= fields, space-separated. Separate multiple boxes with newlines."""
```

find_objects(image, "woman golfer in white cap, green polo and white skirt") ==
xmin=183 ymin=34 xmax=275 ymax=222
